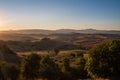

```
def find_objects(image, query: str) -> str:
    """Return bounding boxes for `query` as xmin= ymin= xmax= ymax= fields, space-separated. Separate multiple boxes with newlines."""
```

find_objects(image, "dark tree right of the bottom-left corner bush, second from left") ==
xmin=22 ymin=54 xmax=41 ymax=80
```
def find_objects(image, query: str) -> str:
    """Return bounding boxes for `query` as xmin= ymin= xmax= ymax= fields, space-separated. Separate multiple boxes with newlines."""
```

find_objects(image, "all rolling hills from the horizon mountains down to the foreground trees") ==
xmin=0 ymin=29 xmax=120 ymax=52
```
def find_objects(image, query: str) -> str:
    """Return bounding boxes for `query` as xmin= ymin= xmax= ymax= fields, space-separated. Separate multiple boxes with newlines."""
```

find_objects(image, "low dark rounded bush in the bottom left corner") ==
xmin=0 ymin=62 xmax=20 ymax=80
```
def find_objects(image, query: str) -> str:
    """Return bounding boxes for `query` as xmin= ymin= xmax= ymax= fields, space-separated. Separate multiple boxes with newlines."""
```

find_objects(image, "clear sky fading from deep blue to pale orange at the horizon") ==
xmin=0 ymin=0 xmax=120 ymax=30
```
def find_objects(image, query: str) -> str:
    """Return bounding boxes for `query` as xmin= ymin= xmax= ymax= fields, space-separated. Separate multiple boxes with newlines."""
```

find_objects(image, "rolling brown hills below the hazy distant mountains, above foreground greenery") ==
xmin=0 ymin=33 xmax=120 ymax=52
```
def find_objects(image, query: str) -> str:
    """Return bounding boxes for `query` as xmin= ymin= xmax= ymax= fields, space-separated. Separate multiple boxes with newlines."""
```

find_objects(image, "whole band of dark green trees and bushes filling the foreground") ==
xmin=0 ymin=40 xmax=120 ymax=80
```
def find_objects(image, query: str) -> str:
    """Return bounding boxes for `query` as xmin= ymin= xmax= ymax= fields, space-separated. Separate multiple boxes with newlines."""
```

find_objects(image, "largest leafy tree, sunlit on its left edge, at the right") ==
xmin=86 ymin=40 xmax=120 ymax=78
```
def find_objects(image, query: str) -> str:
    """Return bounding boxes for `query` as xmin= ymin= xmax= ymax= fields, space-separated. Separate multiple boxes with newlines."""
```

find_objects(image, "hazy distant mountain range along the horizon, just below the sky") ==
xmin=2 ymin=29 xmax=120 ymax=34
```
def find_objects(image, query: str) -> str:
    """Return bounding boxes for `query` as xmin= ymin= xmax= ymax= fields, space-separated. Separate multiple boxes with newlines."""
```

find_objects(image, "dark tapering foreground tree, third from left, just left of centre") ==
xmin=39 ymin=55 xmax=60 ymax=80
